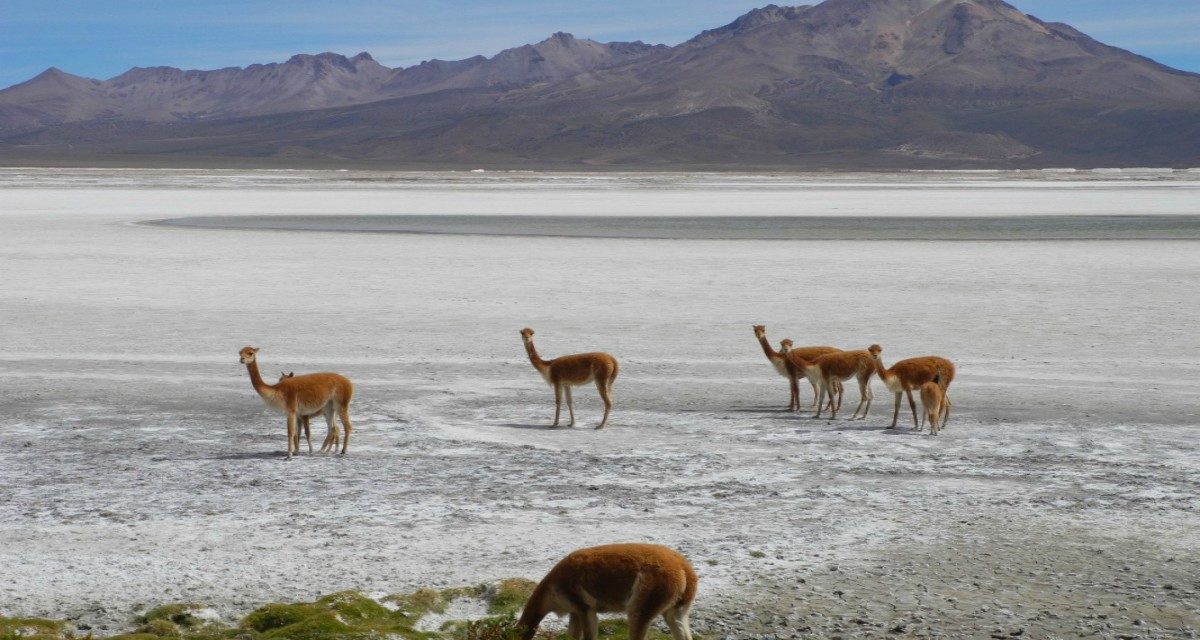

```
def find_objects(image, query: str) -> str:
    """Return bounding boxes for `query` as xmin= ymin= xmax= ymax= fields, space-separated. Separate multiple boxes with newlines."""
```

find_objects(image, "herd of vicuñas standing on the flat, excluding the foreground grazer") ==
xmin=239 ymin=324 xmax=954 ymax=459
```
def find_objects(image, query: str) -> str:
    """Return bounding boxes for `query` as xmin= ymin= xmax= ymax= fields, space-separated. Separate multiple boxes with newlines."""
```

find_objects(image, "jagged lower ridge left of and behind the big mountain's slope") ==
xmin=0 ymin=34 xmax=656 ymax=126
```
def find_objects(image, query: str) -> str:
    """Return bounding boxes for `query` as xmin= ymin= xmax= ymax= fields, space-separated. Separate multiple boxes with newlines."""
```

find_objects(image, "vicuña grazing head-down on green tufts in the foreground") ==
xmin=520 ymin=544 xmax=697 ymax=640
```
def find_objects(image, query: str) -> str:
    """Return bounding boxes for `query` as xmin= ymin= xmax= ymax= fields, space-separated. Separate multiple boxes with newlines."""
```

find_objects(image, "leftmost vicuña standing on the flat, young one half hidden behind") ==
xmin=239 ymin=347 xmax=354 ymax=460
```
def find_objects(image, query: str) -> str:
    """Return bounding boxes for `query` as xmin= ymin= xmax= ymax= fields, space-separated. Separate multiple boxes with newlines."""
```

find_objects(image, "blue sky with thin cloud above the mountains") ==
xmin=0 ymin=0 xmax=1200 ymax=88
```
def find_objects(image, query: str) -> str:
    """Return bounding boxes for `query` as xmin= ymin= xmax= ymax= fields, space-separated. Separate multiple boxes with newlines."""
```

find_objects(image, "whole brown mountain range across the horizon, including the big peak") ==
xmin=0 ymin=0 xmax=1200 ymax=168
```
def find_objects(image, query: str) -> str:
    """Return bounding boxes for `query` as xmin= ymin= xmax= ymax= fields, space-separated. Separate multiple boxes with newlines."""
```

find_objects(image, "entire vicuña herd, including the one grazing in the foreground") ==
xmin=231 ymin=324 xmax=954 ymax=640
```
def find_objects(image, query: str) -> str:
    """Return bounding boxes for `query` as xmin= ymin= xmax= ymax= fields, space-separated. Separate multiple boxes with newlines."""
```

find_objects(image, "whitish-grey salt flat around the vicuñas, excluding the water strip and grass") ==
xmin=0 ymin=169 xmax=1200 ymax=638
